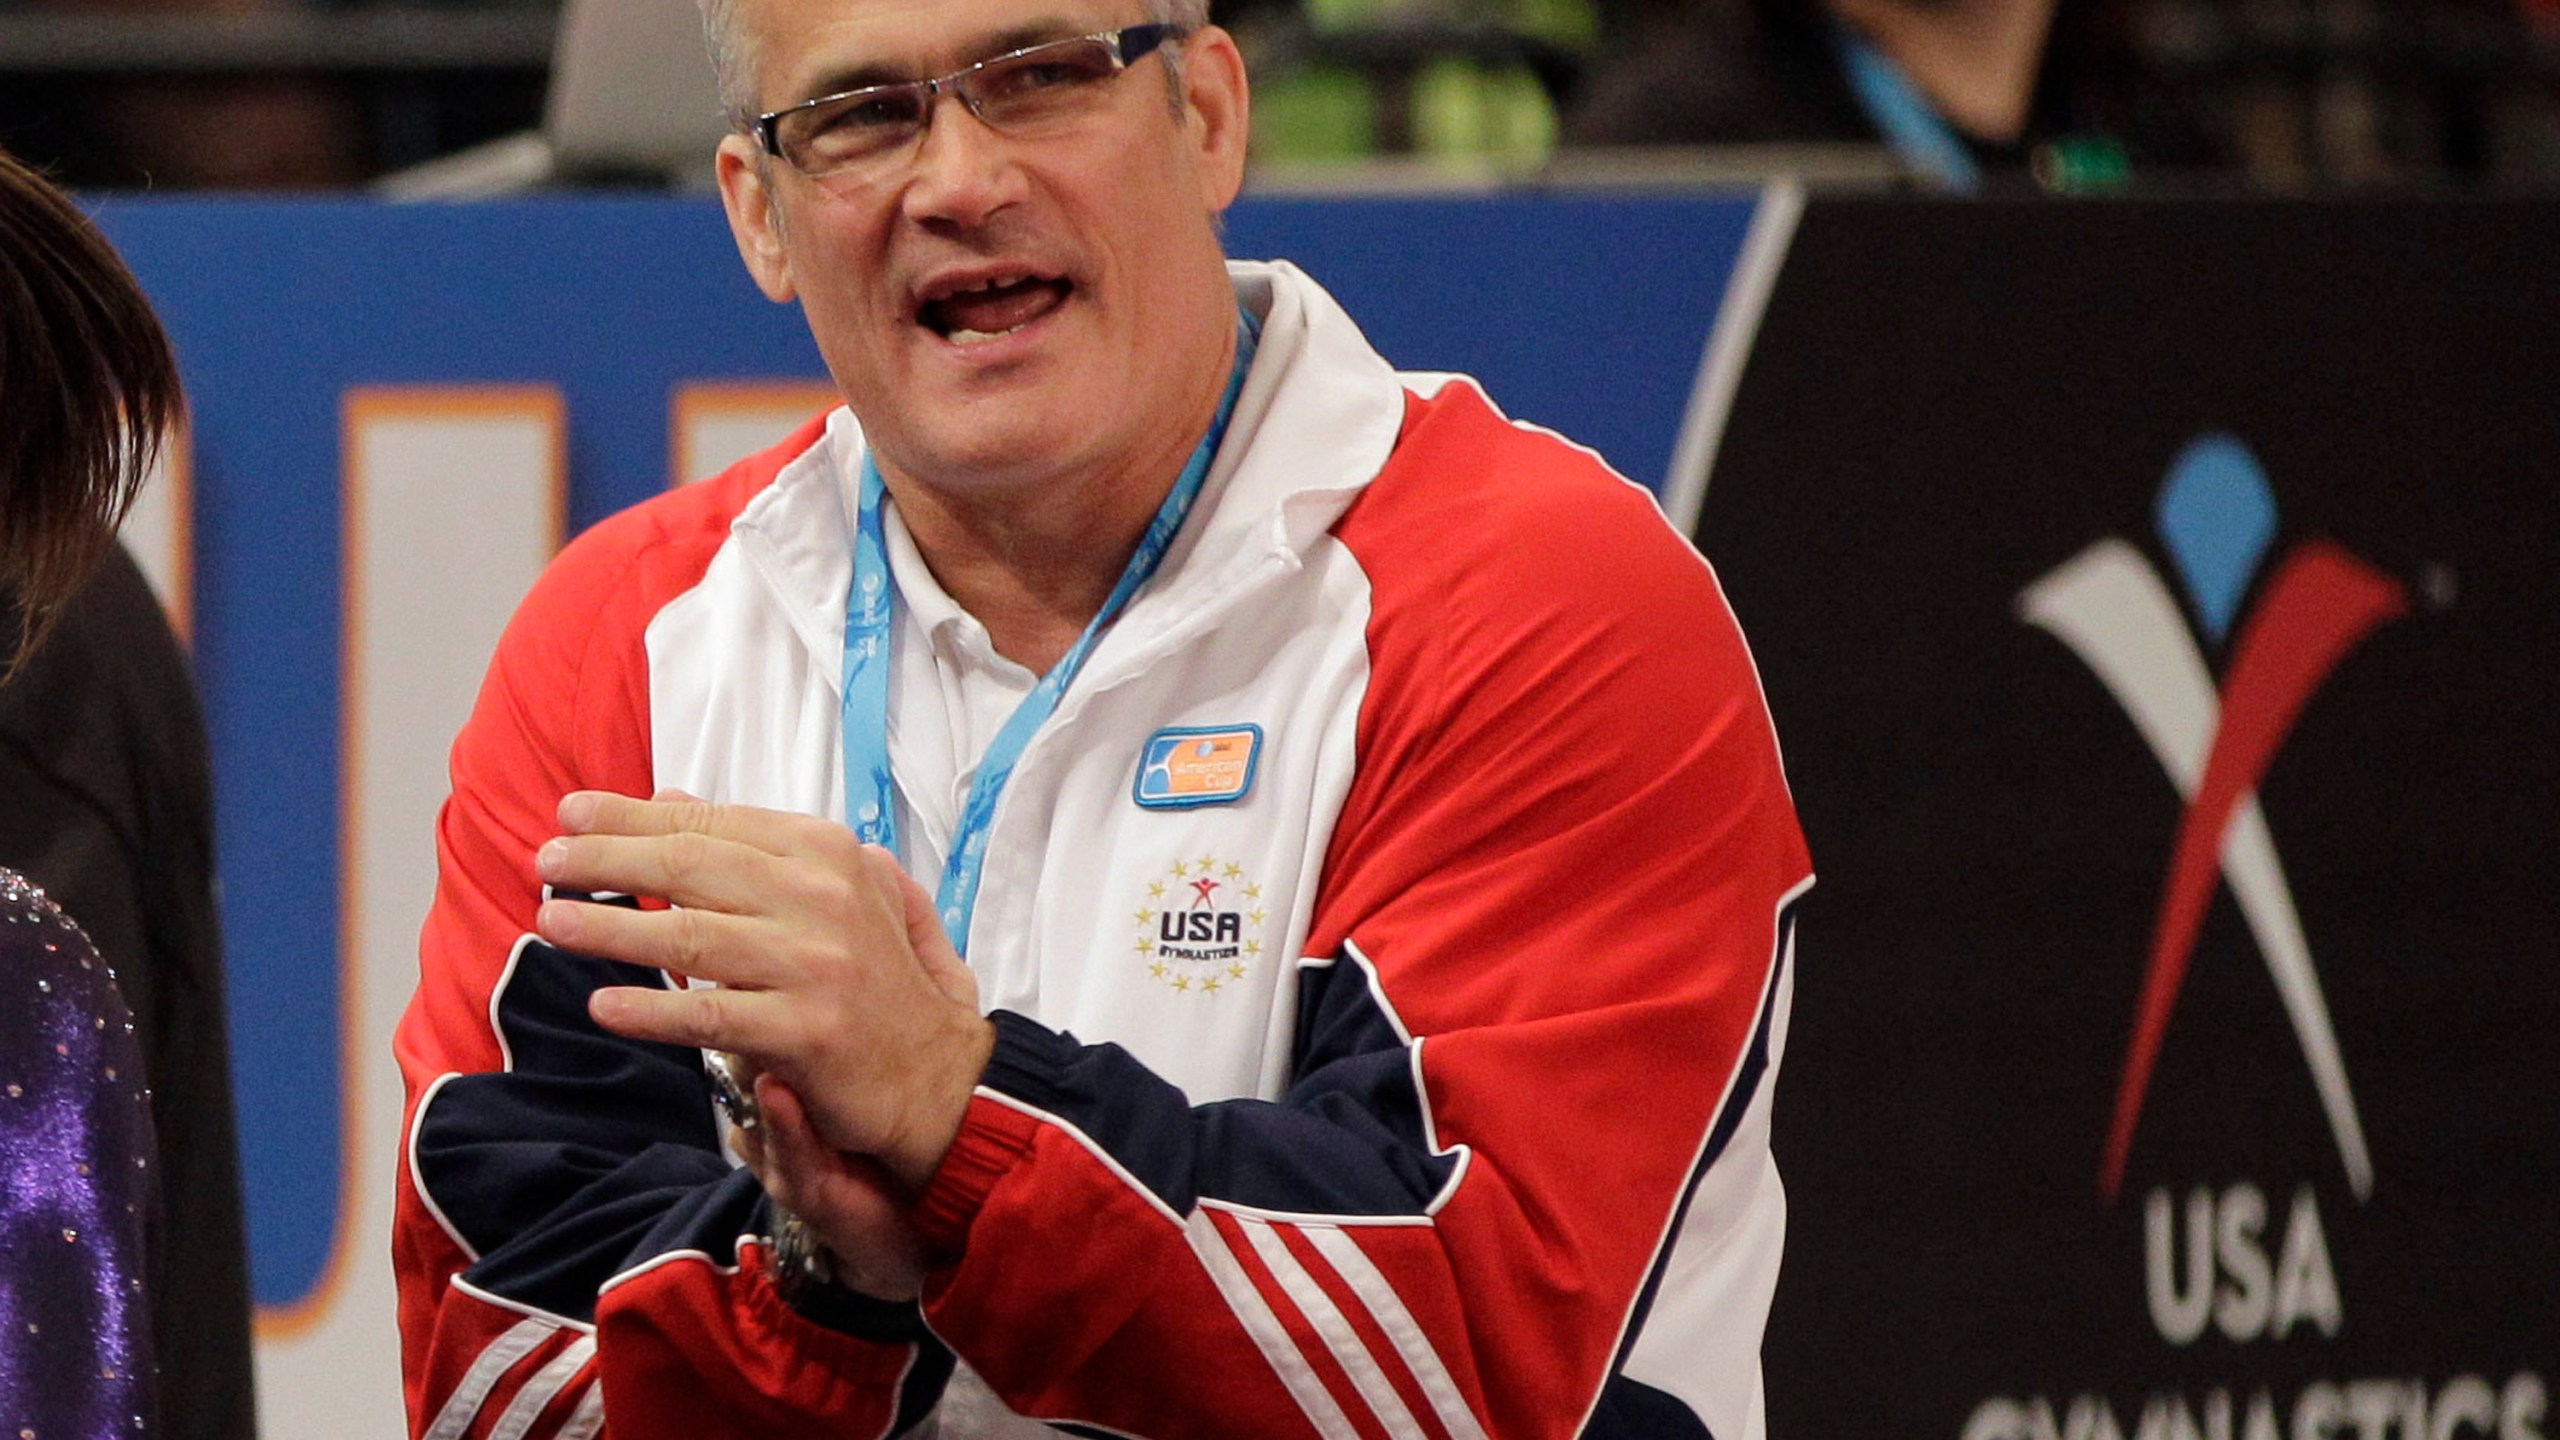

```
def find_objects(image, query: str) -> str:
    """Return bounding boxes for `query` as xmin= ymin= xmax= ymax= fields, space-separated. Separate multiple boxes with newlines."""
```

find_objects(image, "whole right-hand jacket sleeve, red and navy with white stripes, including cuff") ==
xmin=916 ymin=387 xmax=1810 ymax=1440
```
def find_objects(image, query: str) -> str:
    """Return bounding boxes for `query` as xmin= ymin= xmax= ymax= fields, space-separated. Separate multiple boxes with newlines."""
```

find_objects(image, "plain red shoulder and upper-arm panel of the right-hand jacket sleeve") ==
xmin=1308 ymin=384 xmax=1810 ymax=1435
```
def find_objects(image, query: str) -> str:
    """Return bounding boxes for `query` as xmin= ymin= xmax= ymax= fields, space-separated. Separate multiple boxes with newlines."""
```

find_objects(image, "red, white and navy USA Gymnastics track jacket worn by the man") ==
xmin=394 ymin=264 xmax=1810 ymax=1440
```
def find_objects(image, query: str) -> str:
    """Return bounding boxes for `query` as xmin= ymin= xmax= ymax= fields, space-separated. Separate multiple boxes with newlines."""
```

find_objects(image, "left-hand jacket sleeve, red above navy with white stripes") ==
xmin=392 ymin=425 xmax=947 ymax=1440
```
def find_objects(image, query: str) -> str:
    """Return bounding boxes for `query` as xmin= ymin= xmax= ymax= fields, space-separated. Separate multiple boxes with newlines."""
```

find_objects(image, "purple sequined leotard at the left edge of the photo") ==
xmin=0 ymin=869 xmax=156 ymax=1440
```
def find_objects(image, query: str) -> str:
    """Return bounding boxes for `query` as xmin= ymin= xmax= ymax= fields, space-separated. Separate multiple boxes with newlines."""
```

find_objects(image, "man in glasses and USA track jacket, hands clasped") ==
xmin=397 ymin=0 xmax=1810 ymax=1437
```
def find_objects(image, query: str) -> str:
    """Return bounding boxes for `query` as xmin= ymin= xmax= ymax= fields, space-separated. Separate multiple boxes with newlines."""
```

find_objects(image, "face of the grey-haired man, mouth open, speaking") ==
xmin=719 ymin=0 xmax=1244 ymax=492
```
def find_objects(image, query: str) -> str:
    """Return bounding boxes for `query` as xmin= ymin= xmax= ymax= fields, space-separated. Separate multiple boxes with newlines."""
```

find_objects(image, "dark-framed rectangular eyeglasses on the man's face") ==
xmin=755 ymin=26 xmax=1188 ymax=179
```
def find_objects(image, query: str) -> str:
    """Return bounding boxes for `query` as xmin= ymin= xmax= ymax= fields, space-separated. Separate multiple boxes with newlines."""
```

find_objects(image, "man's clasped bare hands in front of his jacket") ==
xmin=535 ymin=792 xmax=996 ymax=1299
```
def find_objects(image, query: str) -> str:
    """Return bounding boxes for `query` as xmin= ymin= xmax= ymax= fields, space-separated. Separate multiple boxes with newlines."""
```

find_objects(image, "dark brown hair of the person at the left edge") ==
xmin=0 ymin=151 xmax=184 ymax=674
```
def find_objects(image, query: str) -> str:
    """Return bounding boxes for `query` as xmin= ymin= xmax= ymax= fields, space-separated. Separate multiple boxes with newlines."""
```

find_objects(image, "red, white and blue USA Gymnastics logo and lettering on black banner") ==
xmin=1964 ymin=433 xmax=2547 ymax=1440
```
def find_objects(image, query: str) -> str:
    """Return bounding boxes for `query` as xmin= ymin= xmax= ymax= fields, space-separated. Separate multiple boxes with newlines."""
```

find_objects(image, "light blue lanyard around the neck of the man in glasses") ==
xmin=842 ymin=313 xmax=1262 ymax=951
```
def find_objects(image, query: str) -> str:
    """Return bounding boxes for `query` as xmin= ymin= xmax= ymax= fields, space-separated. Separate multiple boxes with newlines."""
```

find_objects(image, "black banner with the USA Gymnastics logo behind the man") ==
xmin=1700 ymin=202 xmax=2560 ymax=1440
